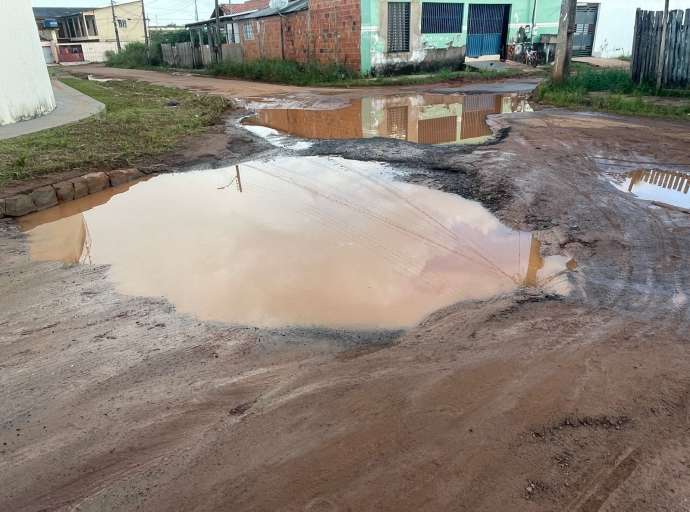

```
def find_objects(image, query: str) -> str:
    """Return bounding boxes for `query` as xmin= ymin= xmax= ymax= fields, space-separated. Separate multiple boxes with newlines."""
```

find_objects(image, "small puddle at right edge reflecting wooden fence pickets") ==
xmin=613 ymin=170 xmax=690 ymax=209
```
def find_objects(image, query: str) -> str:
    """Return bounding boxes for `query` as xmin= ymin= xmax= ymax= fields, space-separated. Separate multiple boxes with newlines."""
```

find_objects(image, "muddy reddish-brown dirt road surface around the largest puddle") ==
xmin=0 ymin=73 xmax=690 ymax=512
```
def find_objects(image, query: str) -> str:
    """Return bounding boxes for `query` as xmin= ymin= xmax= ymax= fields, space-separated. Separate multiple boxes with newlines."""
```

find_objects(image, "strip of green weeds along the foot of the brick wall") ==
xmin=204 ymin=59 xmax=355 ymax=85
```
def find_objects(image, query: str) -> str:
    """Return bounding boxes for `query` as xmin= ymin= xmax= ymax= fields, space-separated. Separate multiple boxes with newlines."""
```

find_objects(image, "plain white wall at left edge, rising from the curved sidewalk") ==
xmin=0 ymin=0 xmax=55 ymax=125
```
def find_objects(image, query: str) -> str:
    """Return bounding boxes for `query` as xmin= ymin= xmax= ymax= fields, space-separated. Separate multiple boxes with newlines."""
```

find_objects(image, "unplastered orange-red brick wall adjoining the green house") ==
xmin=235 ymin=0 xmax=361 ymax=71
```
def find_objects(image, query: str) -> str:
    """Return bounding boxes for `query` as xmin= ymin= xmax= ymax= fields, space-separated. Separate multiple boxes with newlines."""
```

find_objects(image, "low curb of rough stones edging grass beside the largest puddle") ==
xmin=0 ymin=166 xmax=167 ymax=218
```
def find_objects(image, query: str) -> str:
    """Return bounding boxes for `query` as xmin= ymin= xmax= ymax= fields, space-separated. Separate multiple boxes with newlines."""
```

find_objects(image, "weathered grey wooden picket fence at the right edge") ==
xmin=630 ymin=9 xmax=690 ymax=86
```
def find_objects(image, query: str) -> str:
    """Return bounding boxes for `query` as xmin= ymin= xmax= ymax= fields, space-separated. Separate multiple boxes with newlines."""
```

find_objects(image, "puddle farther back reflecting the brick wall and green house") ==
xmin=244 ymin=94 xmax=531 ymax=144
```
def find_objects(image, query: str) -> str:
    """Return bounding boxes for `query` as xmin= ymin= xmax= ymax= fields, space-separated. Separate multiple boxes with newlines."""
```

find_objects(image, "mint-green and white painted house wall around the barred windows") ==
xmin=360 ymin=0 xmax=561 ymax=74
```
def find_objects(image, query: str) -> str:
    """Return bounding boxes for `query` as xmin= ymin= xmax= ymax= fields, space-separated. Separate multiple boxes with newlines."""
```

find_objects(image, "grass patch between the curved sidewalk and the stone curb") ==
xmin=0 ymin=78 xmax=229 ymax=185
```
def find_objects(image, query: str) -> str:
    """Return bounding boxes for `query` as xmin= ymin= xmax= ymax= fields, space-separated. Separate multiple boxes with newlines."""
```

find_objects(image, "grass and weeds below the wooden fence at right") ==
xmin=535 ymin=66 xmax=690 ymax=118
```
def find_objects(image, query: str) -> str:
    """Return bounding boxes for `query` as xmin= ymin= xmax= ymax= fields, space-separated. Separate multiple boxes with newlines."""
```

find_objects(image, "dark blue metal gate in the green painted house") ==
xmin=467 ymin=4 xmax=510 ymax=57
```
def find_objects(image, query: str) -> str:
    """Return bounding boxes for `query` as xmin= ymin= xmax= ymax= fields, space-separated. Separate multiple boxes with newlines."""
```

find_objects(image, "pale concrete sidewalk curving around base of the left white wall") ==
xmin=0 ymin=80 xmax=105 ymax=140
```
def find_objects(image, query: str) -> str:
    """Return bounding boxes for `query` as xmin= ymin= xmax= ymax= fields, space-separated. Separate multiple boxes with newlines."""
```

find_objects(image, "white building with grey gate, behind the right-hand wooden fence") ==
xmin=574 ymin=0 xmax=690 ymax=58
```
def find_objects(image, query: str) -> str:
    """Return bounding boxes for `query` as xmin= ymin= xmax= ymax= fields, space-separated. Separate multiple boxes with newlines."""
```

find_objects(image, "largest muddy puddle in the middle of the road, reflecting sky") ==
xmin=20 ymin=157 xmax=567 ymax=328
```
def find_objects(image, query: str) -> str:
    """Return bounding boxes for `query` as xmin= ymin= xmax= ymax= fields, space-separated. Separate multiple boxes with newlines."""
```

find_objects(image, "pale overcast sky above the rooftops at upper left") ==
xmin=31 ymin=0 xmax=219 ymax=25
